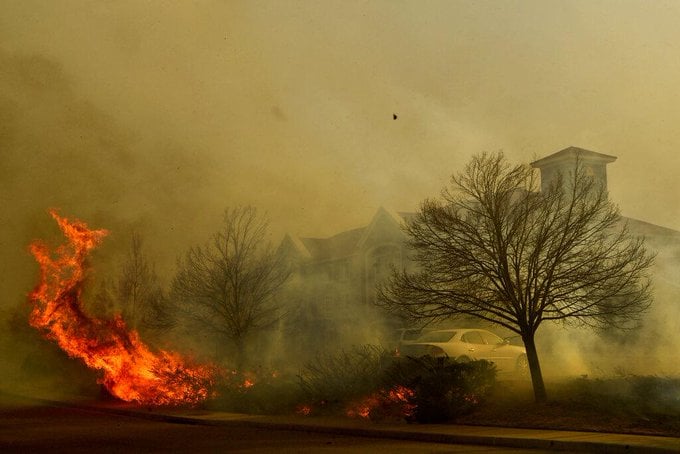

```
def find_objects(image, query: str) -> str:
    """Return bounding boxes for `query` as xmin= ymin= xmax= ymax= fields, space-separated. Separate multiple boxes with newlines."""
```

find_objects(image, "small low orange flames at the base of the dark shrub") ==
xmin=346 ymin=385 xmax=416 ymax=418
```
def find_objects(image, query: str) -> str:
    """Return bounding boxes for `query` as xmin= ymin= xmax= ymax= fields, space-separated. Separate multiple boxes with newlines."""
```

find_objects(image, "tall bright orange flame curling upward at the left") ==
xmin=29 ymin=211 xmax=217 ymax=405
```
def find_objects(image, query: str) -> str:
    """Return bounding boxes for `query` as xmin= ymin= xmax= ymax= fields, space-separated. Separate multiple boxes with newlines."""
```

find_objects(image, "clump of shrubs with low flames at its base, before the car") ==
xmin=299 ymin=346 xmax=496 ymax=423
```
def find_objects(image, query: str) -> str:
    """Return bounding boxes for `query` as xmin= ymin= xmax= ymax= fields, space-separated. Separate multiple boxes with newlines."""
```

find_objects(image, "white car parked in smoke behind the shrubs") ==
xmin=400 ymin=328 xmax=529 ymax=374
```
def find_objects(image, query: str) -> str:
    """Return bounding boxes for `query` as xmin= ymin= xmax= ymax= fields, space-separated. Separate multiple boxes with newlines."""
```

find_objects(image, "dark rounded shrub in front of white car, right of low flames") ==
xmin=385 ymin=356 xmax=496 ymax=423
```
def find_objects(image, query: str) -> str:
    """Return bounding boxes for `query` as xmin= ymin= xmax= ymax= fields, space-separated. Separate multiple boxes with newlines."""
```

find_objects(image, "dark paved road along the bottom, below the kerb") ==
xmin=0 ymin=397 xmax=545 ymax=454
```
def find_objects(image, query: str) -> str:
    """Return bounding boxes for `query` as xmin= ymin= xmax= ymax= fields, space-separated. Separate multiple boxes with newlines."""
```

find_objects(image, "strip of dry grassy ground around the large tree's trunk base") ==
xmin=455 ymin=376 xmax=680 ymax=436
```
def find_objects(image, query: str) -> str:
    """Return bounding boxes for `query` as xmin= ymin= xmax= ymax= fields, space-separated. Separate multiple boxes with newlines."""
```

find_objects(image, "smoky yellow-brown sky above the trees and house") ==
xmin=0 ymin=0 xmax=680 ymax=294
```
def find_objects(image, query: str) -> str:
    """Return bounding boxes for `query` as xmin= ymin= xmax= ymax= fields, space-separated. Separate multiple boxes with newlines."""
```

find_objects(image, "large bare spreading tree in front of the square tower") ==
xmin=379 ymin=153 xmax=653 ymax=402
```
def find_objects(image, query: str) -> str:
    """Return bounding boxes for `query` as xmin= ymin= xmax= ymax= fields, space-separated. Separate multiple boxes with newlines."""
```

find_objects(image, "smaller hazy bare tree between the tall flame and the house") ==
xmin=172 ymin=206 xmax=290 ymax=367
